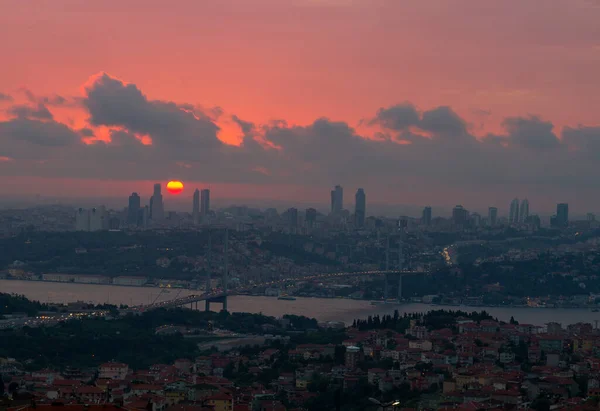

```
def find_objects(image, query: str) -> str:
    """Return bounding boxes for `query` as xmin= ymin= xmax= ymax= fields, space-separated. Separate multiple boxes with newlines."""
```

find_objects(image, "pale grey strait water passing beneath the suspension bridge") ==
xmin=0 ymin=280 xmax=600 ymax=325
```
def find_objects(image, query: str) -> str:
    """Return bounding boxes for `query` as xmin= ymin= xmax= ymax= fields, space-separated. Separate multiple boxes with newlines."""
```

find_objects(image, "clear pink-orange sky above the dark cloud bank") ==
xmin=0 ymin=0 xmax=600 ymax=211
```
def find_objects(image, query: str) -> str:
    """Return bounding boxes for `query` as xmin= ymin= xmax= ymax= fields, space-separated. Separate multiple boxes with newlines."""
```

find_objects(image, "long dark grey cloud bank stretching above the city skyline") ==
xmin=0 ymin=73 xmax=600 ymax=208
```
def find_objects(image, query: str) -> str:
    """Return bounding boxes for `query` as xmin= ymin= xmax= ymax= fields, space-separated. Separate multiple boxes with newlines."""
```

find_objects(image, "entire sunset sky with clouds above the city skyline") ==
xmin=0 ymin=0 xmax=600 ymax=212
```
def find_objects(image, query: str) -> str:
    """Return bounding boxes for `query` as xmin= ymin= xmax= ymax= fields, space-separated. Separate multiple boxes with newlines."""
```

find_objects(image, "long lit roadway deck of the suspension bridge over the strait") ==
xmin=130 ymin=270 xmax=426 ymax=312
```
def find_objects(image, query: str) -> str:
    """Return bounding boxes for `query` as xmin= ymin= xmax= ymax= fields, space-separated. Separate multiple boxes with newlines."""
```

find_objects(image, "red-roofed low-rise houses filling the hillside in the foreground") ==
xmin=1 ymin=317 xmax=600 ymax=411
